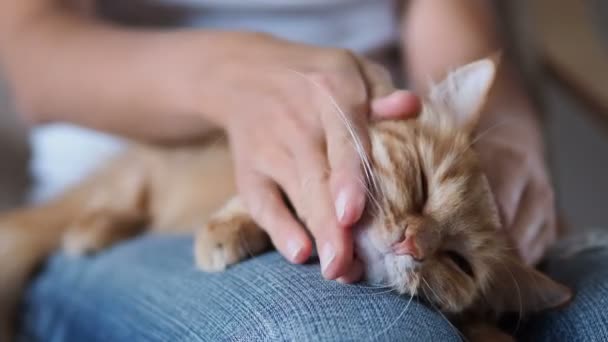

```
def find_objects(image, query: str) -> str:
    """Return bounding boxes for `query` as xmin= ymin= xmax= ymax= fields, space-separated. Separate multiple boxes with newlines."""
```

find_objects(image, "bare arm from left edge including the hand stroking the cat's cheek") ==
xmin=0 ymin=0 xmax=416 ymax=278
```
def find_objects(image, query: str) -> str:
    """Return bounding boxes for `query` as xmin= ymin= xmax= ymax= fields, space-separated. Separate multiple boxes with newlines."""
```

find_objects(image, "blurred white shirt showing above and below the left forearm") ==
xmin=30 ymin=0 xmax=397 ymax=201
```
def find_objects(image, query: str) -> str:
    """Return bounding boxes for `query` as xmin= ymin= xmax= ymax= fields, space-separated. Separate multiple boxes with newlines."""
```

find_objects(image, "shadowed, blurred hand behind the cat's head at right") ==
xmin=476 ymin=125 xmax=557 ymax=264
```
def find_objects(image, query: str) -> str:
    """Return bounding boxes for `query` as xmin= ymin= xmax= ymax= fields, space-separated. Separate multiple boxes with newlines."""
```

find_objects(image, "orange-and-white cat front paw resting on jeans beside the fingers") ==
xmin=194 ymin=197 xmax=271 ymax=272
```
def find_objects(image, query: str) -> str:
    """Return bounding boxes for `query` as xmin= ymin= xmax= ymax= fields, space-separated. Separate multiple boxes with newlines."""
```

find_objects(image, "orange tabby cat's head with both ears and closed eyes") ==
xmin=355 ymin=58 xmax=571 ymax=314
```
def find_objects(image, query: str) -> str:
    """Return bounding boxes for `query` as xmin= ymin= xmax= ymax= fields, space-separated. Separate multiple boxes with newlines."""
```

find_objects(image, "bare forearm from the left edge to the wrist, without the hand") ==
xmin=0 ymin=1 xmax=238 ymax=141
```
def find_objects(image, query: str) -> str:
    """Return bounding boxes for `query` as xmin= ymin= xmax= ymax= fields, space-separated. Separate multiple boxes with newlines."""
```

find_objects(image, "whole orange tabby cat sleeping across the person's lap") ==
xmin=0 ymin=59 xmax=571 ymax=340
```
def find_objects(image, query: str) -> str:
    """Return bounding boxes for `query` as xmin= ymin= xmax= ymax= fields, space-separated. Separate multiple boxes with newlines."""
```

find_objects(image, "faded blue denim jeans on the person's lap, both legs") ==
xmin=16 ymin=236 xmax=608 ymax=342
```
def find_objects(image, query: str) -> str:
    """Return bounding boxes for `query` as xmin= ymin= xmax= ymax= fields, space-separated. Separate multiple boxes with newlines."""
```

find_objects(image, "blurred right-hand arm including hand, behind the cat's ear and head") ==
xmin=402 ymin=0 xmax=556 ymax=262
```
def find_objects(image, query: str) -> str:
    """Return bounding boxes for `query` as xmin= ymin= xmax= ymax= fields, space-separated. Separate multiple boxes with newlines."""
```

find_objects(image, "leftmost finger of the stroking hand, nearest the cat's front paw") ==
xmin=239 ymin=172 xmax=312 ymax=263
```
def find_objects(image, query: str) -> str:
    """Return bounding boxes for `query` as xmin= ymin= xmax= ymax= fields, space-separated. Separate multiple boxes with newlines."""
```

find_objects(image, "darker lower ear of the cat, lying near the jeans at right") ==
xmin=486 ymin=257 xmax=572 ymax=313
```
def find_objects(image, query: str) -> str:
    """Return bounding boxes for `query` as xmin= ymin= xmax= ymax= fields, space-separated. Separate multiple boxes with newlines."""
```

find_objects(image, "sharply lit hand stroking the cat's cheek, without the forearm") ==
xmin=215 ymin=35 xmax=420 ymax=281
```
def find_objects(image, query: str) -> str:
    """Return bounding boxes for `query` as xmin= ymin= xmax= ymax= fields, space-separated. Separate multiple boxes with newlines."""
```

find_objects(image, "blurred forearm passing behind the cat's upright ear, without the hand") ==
xmin=402 ymin=0 xmax=542 ymax=151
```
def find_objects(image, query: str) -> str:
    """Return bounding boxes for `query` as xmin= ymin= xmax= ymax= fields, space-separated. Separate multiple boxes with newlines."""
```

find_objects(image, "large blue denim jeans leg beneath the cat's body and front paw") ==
xmin=22 ymin=238 xmax=460 ymax=342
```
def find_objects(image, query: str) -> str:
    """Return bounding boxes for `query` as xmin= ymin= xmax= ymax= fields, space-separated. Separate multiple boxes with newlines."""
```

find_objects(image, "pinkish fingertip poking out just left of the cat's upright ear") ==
xmin=371 ymin=90 xmax=422 ymax=120
